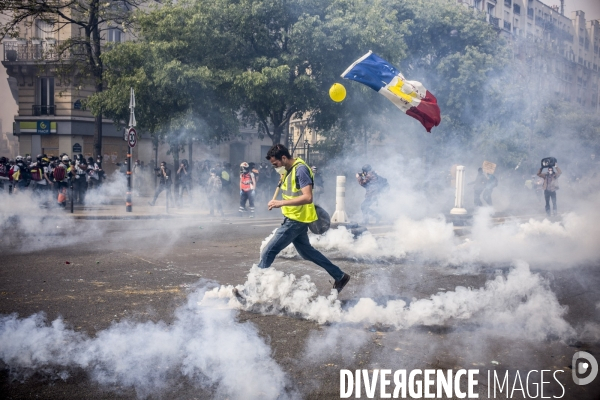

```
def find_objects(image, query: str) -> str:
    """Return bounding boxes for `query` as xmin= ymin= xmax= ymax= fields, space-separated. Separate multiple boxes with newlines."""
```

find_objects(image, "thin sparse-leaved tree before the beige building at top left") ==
xmin=0 ymin=0 xmax=143 ymax=156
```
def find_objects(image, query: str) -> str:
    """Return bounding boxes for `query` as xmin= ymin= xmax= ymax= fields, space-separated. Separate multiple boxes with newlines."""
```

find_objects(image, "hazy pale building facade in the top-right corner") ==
xmin=458 ymin=0 xmax=600 ymax=112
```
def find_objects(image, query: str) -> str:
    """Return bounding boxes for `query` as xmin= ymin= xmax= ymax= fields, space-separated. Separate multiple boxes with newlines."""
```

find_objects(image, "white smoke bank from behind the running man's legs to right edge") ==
xmin=261 ymin=195 xmax=600 ymax=269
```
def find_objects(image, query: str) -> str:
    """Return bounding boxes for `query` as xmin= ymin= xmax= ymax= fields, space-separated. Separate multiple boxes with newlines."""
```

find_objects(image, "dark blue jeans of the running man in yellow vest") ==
xmin=258 ymin=218 xmax=344 ymax=281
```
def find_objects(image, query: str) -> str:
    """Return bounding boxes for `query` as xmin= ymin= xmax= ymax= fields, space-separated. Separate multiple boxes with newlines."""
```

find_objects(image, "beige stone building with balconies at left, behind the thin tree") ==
xmin=0 ymin=13 xmax=271 ymax=173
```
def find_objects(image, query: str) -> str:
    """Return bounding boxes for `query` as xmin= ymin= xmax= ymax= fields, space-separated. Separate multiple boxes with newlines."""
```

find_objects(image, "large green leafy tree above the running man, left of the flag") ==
xmin=90 ymin=0 xmax=404 ymax=144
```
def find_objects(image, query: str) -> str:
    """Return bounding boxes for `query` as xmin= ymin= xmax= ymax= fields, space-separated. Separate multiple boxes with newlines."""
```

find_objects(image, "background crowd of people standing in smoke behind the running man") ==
xmin=0 ymin=154 xmax=595 ymax=219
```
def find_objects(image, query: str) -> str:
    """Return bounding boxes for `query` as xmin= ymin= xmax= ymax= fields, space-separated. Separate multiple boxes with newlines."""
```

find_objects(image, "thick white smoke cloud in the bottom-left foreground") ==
xmin=0 ymin=289 xmax=296 ymax=399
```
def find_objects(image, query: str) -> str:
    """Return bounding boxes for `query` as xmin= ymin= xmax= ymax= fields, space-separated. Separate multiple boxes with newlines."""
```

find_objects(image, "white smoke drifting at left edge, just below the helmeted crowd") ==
xmin=0 ymin=173 xmax=204 ymax=253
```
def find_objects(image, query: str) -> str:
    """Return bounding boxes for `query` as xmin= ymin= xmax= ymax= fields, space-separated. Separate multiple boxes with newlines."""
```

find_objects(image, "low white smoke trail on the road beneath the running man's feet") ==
xmin=200 ymin=262 xmax=575 ymax=340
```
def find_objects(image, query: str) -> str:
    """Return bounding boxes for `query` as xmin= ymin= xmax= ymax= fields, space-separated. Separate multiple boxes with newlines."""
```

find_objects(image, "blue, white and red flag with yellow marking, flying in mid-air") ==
xmin=342 ymin=51 xmax=441 ymax=132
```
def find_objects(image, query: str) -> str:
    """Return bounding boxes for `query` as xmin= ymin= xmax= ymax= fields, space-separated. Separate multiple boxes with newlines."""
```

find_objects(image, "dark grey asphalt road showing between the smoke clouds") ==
xmin=0 ymin=218 xmax=600 ymax=399
